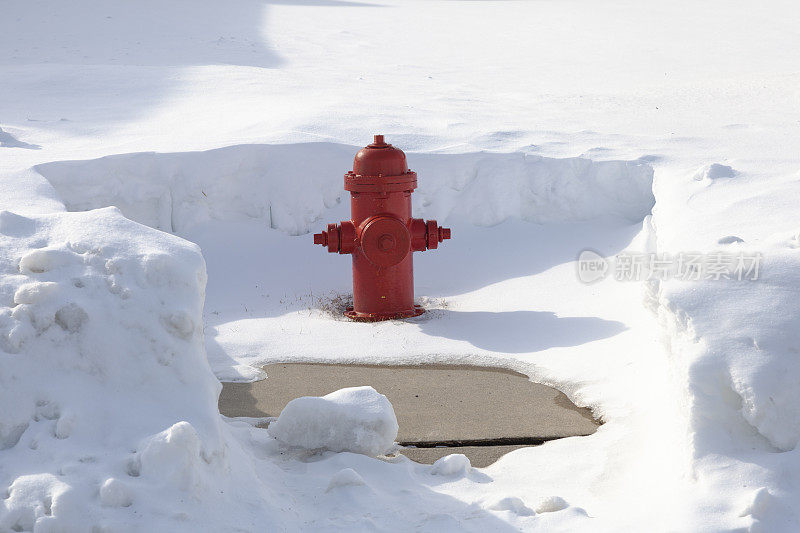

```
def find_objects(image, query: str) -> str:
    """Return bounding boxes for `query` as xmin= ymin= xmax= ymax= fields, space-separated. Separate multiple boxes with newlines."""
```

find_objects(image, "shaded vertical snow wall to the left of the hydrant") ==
xmin=36 ymin=143 xmax=353 ymax=235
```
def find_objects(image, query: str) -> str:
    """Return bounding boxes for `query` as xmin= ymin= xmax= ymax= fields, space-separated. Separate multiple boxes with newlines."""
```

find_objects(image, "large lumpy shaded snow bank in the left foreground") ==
xmin=0 ymin=208 xmax=288 ymax=531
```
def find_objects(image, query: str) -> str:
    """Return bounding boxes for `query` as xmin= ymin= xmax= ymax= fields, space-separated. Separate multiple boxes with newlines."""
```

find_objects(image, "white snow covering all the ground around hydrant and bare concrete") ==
xmin=0 ymin=0 xmax=800 ymax=532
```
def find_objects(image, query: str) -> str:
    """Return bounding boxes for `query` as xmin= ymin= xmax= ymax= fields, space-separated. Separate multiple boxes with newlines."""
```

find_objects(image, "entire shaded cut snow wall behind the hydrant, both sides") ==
xmin=36 ymin=143 xmax=655 ymax=235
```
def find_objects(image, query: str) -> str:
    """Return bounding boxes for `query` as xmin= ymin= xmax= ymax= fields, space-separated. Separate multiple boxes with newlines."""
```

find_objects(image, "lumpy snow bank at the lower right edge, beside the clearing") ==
xmin=649 ymin=234 xmax=800 ymax=531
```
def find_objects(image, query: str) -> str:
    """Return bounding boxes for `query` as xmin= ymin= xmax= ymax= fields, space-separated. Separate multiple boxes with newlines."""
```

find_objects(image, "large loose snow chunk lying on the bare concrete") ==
xmin=269 ymin=387 xmax=398 ymax=456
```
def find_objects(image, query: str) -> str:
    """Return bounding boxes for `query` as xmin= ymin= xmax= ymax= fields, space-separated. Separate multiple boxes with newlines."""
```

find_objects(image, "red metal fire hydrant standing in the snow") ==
xmin=314 ymin=135 xmax=450 ymax=322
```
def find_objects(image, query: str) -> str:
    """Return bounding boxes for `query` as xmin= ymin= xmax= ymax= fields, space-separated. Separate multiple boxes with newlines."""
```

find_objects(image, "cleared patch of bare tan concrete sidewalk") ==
xmin=219 ymin=363 xmax=599 ymax=466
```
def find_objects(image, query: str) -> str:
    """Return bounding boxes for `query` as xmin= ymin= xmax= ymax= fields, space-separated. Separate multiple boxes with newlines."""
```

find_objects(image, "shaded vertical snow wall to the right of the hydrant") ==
xmin=409 ymin=153 xmax=655 ymax=226
